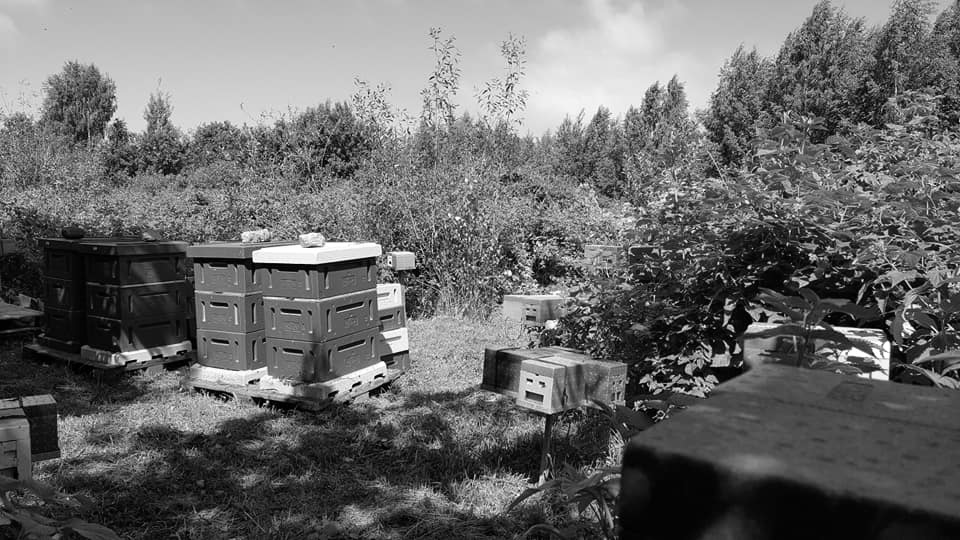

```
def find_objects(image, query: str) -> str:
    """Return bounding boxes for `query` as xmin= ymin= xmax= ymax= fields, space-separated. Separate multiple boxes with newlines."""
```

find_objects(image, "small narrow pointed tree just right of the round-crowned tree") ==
xmin=138 ymin=90 xmax=183 ymax=174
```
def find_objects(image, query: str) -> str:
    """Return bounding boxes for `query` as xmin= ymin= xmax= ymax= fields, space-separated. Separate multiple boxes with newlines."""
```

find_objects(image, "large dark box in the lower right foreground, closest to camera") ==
xmin=620 ymin=364 xmax=960 ymax=540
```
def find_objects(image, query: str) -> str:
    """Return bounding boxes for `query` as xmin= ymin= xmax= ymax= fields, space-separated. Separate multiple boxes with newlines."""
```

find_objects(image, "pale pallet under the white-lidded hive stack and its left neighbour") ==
xmin=181 ymin=362 xmax=403 ymax=411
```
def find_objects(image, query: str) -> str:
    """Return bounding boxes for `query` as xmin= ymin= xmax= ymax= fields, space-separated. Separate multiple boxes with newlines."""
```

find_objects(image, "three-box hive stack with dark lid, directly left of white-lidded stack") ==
xmin=187 ymin=242 xmax=290 ymax=371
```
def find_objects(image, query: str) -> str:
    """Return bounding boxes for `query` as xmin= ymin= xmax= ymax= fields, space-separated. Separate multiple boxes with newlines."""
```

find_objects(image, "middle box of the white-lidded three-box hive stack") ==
xmin=263 ymin=289 xmax=378 ymax=341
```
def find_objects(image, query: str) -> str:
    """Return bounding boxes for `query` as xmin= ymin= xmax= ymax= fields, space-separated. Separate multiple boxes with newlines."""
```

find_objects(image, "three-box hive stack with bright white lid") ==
xmin=253 ymin=242 xmax=381 ymax=383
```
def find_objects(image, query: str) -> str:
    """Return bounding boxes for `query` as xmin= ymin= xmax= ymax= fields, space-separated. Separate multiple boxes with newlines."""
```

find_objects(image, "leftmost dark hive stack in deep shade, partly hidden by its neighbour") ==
xmin=37 ymin=238 xmax=135 ymax=353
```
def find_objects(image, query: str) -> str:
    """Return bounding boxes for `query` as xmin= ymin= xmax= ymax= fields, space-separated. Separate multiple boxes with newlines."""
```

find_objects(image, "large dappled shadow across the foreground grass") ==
xmin=45 ymin=382 xmax=612 ymax=539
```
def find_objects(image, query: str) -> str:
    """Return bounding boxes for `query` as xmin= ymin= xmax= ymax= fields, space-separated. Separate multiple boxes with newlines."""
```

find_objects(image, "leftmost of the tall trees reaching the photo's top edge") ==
xmin=767 ymin=0 xmax=866 ymax=136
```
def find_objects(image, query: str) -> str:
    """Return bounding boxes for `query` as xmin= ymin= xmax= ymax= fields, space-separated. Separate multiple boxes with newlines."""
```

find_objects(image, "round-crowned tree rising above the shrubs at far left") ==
xmin=41 ymin=60 xmax=117 ymax=143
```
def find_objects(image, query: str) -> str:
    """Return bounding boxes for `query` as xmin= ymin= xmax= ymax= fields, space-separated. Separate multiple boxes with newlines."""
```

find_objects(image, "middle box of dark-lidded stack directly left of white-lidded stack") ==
xmin=194 ymin=291 xmax=264 ymax=334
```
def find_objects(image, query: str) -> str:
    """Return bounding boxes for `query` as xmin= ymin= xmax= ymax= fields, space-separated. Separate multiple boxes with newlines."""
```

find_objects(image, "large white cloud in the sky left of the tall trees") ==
xmin=525 ymin=0 xmax=703 ymax=133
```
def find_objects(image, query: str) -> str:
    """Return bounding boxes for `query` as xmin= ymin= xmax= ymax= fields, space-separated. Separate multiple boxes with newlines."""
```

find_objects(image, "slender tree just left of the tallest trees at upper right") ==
xmin=704 ymin=45 xmax=770 ymax=166
